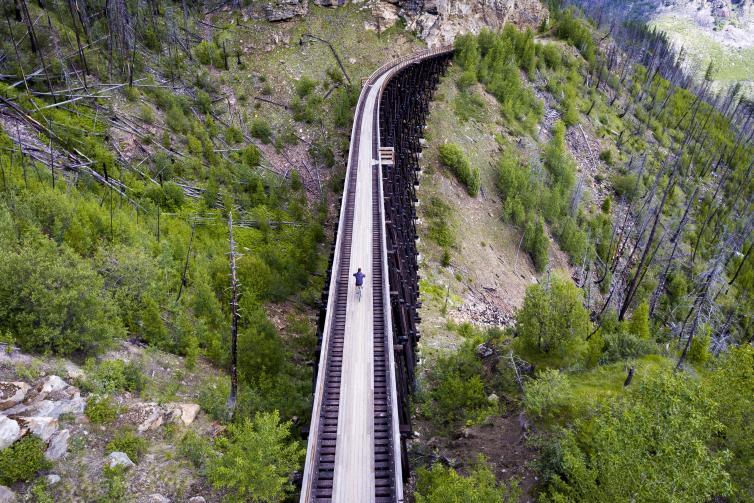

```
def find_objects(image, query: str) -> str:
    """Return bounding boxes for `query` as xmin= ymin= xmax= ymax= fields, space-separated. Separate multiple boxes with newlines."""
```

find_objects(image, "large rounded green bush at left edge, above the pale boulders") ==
xmin=0 ymin=237 xmax=125 ymax=355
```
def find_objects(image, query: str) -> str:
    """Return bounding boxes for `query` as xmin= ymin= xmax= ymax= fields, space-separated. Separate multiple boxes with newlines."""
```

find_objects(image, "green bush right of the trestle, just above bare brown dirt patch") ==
xmin=421 ymin=340 xmax=495 ymax=432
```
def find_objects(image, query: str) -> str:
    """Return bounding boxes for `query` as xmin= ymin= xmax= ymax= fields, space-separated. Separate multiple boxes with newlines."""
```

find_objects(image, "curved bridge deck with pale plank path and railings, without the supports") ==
xmin=300 ymin=49 xmax=449 ymax=503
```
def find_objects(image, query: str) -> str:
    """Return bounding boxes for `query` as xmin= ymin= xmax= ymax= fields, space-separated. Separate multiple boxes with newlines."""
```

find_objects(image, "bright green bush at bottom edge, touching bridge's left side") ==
xmin=207 ymin=411 xmax=305 ymax=502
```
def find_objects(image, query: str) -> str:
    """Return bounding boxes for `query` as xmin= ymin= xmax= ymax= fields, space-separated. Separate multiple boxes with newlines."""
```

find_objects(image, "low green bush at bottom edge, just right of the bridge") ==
xmin=414 ymin=457 xmax=521 ymax=503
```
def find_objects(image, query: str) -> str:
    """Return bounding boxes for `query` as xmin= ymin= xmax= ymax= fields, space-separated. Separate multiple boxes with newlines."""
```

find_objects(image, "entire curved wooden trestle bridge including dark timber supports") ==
xmin=301 ymin=49 xmax=452 ymax=503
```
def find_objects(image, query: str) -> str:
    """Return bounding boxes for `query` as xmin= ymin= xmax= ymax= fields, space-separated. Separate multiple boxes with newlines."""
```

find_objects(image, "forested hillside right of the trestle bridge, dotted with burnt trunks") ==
xmin=414 ymin=2 xmax=754 ymax=502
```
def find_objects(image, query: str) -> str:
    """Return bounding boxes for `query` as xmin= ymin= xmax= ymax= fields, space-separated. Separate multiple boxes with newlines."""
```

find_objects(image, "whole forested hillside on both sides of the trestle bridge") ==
xmin=0 ymin=0 xmax=754 ymax=503
